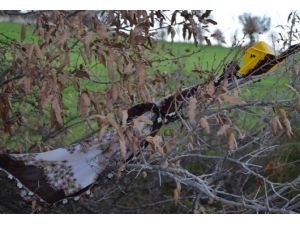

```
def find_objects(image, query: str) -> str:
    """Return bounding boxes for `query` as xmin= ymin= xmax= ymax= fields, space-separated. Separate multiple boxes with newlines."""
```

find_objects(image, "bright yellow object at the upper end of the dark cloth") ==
xmin=239 ymin=41 xmax=277 ymax=75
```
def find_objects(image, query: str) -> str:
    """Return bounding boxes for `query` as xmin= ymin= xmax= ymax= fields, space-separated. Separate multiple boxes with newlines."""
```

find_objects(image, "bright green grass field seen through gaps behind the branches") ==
xmin=0 ymin=23 xmax=298 ymax=148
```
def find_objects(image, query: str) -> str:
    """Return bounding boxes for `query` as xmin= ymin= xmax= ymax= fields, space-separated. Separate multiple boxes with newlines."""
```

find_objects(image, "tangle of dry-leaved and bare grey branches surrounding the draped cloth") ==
xmin=0 ymin=10 xmax=300 ymax=213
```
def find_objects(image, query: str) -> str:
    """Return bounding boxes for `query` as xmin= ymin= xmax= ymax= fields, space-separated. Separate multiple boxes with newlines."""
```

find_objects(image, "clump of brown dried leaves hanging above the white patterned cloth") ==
xmin=0 ymin=10 xmax=216 ymax=147
